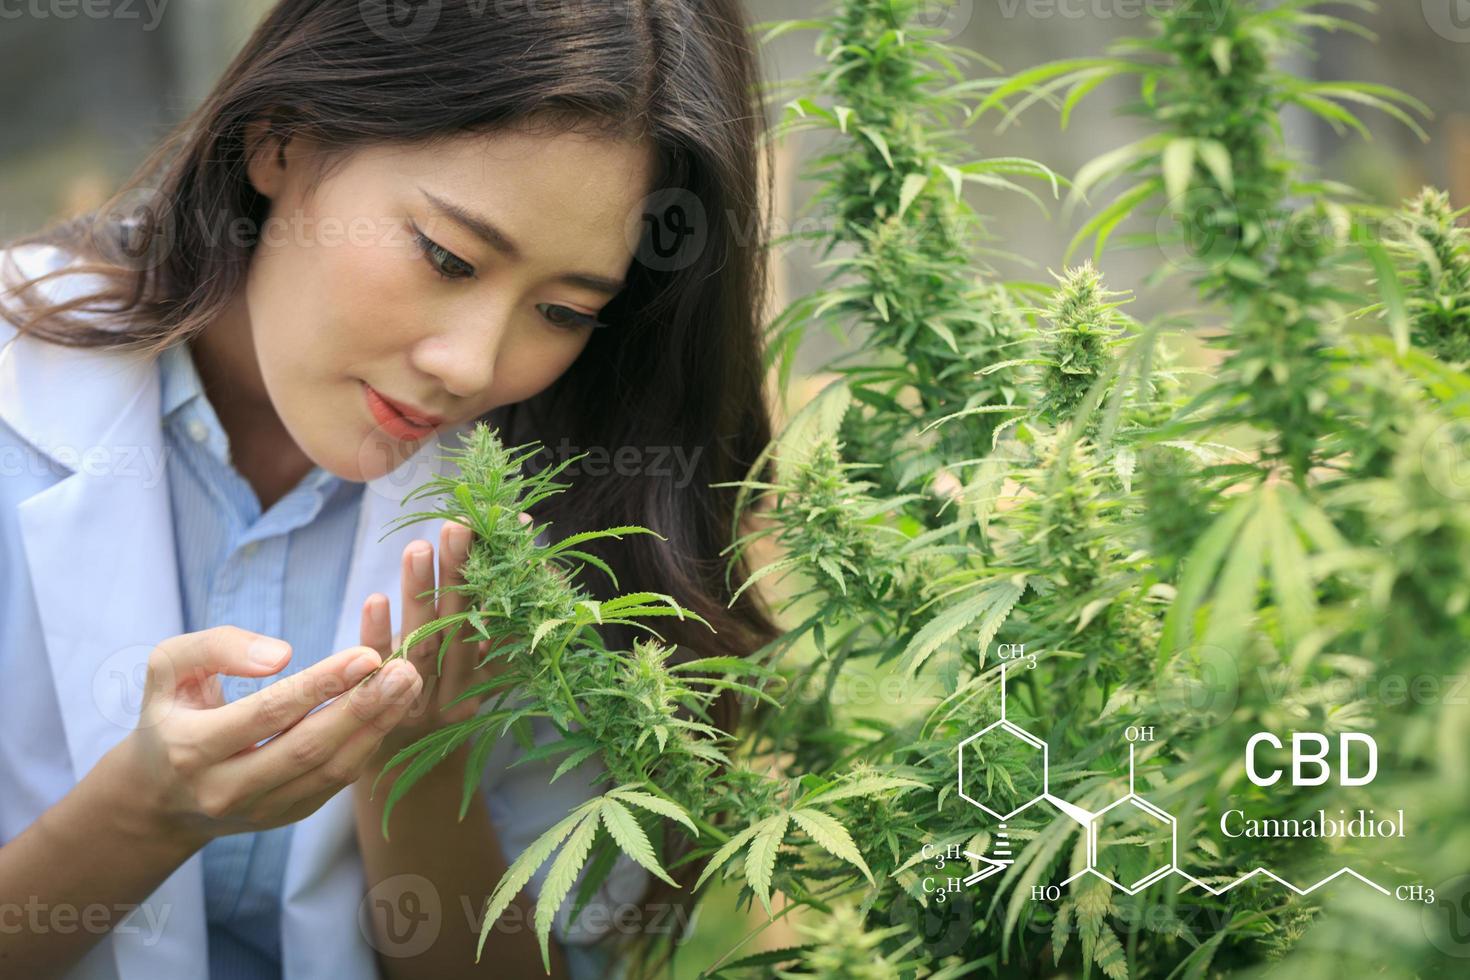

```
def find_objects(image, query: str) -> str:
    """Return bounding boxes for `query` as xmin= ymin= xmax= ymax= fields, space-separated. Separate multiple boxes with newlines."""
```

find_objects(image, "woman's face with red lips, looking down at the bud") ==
xmin=229 ymin=124 xmax=654 ymax=480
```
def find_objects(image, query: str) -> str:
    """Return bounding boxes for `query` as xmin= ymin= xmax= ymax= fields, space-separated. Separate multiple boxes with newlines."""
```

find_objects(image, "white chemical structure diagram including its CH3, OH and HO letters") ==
xmin=922 ymin=644 xmax=1435 ymax=904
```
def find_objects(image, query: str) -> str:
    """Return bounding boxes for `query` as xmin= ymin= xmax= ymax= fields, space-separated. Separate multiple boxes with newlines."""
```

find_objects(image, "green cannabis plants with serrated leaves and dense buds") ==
xmin=385 ymin=0 xmax=1470 ymax=980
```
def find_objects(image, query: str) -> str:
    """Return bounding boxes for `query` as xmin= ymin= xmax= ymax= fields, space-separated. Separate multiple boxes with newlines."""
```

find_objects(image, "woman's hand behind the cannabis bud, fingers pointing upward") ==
xmin=362 ymin=513 xmax=531 ymax=779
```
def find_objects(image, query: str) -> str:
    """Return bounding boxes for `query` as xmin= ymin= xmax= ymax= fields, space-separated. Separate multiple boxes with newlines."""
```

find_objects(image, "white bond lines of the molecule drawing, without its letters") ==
xmin=958 ymin=658 xmax=1387 ymax=901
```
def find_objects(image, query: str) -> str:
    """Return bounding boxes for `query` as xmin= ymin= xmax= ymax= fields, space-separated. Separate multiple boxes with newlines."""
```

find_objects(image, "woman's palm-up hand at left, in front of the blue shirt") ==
xmin=123 ymin=626 xmax=420 ymax=846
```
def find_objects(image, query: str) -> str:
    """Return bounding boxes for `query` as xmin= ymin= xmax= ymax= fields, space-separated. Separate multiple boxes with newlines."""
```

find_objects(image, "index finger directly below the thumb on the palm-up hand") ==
xmin=188 ymin=646 xmax=381 ymax=761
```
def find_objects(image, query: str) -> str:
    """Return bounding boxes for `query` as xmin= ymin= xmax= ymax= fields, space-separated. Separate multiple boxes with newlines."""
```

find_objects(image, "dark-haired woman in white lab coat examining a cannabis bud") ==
xmin=0 ymin=0 xmax=773 ymax=980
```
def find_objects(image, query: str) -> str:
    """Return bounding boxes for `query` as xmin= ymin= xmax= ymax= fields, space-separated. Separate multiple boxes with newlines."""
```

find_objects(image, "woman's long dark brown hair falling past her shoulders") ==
xmin=7 ymin=0 xmax=778 ymax=963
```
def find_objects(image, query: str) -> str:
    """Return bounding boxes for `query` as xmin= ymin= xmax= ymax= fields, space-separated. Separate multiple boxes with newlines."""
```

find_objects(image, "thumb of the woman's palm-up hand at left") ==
xmin=144 ymin=626 xmax=291 ymax=707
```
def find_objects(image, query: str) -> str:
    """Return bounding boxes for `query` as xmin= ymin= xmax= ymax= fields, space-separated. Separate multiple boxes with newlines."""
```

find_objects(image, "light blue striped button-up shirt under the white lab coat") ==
xmin=159 ymin=344 xmax=363 ymax=980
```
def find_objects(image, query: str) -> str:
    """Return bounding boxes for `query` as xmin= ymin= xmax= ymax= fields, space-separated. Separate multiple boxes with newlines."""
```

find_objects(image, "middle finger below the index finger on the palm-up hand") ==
xmin=209 ymin=660 xmax=423 ymax=796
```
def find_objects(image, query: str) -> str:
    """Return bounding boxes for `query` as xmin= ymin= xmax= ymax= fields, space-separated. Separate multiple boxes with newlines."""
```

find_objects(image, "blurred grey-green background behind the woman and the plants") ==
xmin=0 ymin=0 xmax=1470 ymax=977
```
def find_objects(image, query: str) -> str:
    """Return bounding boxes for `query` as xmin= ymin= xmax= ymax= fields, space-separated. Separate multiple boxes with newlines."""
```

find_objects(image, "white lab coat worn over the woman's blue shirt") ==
xmin=0 ymin=245 xmax=645 ymax=980
